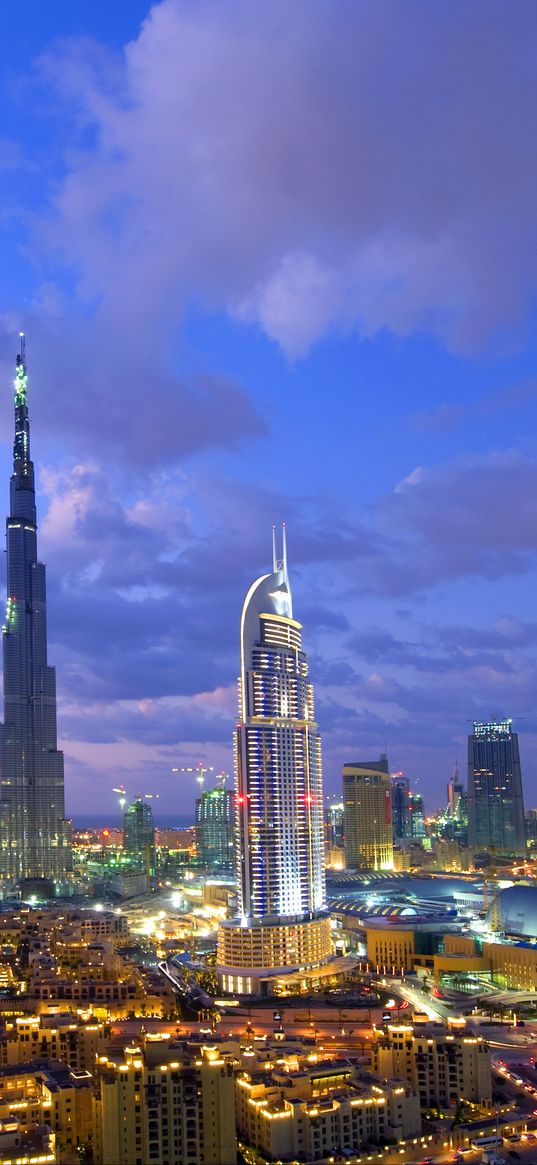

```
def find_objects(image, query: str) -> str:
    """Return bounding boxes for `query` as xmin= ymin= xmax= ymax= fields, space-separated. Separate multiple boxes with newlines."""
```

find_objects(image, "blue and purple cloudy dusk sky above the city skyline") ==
xmin=0 ymin=0 xmax=537 ymax=817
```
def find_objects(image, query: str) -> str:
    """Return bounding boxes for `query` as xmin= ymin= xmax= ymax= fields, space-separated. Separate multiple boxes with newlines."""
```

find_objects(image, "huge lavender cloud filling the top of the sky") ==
xmin=29 ymin=0 xmax=537 ymax=355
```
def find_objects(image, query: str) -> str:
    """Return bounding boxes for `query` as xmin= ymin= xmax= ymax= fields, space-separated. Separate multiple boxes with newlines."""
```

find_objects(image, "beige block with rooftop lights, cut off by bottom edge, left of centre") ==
xmin=93 ymin=1036 xmax=236 ymax=1165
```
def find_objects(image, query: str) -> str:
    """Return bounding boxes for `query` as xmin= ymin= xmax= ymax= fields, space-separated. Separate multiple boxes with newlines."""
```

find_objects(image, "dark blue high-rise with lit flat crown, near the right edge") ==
xmin=468 ymin=720 xmax=525 ymax=856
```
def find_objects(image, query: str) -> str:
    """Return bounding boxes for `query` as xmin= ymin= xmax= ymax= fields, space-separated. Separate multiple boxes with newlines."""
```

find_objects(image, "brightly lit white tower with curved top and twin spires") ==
xmin=218 ymin=531 xmax=332 ymax=995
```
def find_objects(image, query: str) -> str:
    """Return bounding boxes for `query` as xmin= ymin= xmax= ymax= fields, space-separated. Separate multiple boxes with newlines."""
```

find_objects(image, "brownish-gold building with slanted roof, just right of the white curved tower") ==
xmin=342 ymin=756 xmax=394 ymax=870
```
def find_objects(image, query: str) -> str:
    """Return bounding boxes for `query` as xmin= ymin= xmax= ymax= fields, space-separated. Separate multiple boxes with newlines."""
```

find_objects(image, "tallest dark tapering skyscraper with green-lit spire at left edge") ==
xmin=0 ymin=337 xmax=71 ymax=885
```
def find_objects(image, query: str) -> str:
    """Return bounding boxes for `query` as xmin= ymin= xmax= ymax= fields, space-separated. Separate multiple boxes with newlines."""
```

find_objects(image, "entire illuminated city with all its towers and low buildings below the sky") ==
xmin=0 ymin=333 xmax=537 ymax=1165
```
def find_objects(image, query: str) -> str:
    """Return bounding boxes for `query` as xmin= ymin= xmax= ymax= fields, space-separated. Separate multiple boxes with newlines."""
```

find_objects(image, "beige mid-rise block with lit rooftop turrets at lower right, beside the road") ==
xmin=372 ymin=1021 xmax=493 ymax=1108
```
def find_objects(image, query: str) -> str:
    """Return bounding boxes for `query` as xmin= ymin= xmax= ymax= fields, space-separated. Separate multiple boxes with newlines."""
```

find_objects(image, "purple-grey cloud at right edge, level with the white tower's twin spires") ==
xmin=363 ymin=451 xmax=537 ymax=594
